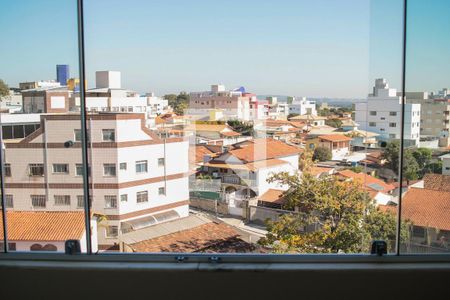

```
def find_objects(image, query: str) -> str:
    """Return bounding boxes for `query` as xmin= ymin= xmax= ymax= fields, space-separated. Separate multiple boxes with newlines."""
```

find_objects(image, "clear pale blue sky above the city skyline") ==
xmin=0 ymin=0 xmax=450 ymax=97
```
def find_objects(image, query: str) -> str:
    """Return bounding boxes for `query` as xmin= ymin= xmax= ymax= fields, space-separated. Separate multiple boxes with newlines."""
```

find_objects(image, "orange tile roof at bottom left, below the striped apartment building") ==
xmin=0 ymin=211 xmax=85 ymax=241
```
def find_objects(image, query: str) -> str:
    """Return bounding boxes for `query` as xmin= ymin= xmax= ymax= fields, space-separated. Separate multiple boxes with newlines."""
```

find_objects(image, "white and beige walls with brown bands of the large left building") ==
xmin=5 ymin=114 xmax=189 ymax=244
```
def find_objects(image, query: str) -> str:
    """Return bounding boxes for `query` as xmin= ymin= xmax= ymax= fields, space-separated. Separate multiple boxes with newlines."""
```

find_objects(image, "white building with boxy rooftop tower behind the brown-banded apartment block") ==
xmin=70 ymin=71 xmax=169 ymax=127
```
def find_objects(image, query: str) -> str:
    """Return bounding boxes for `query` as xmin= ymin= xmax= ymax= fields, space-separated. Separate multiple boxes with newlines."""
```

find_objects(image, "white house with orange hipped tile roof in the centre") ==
xmin=202 ymin=138 xmax=300 ymax=216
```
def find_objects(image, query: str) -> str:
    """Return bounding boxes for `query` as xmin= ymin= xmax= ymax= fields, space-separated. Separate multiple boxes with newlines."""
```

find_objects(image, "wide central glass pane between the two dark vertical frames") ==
xmin=79 ymin=0 xmax=406 ymax=254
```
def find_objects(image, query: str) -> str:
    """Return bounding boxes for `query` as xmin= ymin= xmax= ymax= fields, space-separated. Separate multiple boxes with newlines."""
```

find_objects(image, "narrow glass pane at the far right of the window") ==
xmin=401 ymin=0 xmax=450 ymax=254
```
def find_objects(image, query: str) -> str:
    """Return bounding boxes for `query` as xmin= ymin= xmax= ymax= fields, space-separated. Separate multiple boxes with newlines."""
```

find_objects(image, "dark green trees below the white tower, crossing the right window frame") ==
xmin=383 ymin=141 xmax=442 ymax=180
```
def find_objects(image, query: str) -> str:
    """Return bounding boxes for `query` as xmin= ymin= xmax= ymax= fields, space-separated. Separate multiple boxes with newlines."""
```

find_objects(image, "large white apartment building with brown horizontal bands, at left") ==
xmin=5 ymin=113 xmax=189 ymax=250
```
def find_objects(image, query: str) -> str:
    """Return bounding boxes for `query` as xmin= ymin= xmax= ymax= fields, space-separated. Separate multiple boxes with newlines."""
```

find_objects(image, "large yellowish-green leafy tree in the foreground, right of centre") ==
xmin=259 ymin=173 xmax=409 ymax=253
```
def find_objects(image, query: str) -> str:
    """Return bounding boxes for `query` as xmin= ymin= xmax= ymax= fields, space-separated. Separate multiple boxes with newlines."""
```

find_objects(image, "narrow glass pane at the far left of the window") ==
xmin=0 ymin=0 xmax=92 ymax=253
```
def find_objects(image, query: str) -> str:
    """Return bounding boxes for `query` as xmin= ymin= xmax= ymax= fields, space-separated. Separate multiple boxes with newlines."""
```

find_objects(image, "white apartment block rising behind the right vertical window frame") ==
xmin=355 ymin=78 xmax=421 ymax=145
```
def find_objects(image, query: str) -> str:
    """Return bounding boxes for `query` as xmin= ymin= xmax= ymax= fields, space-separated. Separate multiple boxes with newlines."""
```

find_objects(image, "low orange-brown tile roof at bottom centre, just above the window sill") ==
xmin=129 ymin=222 xmax=255 ymax=253
